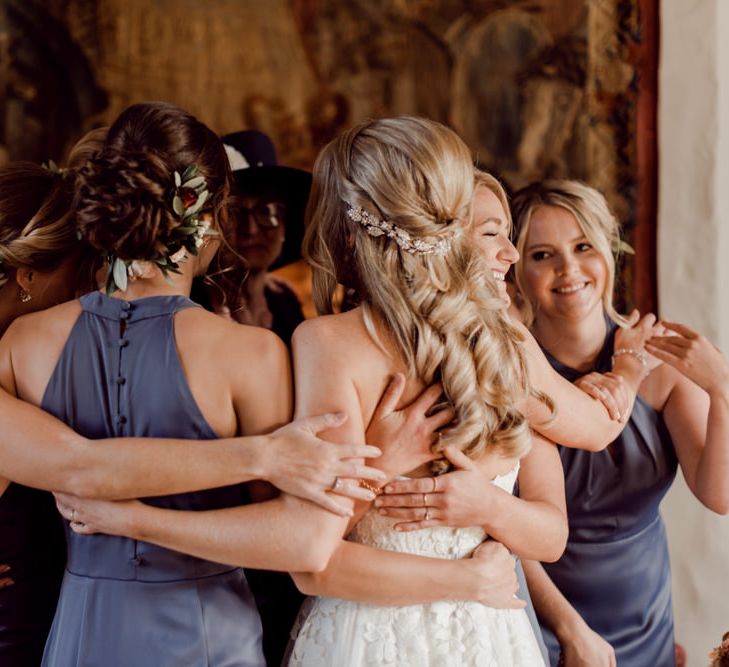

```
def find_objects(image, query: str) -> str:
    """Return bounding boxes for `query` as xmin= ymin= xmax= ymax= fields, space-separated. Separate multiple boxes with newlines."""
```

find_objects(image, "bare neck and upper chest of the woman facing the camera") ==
xmin=531 ymin=308 xmax=607 ymax=371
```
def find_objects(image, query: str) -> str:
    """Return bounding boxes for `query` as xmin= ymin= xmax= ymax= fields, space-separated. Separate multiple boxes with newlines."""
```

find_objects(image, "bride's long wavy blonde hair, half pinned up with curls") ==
xmin=304 ymin=117 xmax=531 ymax=472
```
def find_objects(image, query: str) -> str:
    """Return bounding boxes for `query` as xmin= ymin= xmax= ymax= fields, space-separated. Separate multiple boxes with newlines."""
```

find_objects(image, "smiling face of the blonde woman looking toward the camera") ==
xmin=522 ymin=206 xmax=608 ymax=328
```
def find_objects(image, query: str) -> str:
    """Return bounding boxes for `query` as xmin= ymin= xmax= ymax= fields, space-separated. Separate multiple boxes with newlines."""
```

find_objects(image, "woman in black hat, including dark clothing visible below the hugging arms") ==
xmin=192 ymin=130 xmax=311 ymax=665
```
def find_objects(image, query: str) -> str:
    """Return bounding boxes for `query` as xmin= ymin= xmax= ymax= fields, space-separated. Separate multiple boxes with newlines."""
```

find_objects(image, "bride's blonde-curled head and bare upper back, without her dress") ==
xmin=294 ymin=117 xmax=529 ymax=478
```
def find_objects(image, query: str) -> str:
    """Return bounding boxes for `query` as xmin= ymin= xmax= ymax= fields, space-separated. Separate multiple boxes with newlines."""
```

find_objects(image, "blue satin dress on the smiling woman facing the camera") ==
xmin=542 ymin=322 xmax=678 ymax=667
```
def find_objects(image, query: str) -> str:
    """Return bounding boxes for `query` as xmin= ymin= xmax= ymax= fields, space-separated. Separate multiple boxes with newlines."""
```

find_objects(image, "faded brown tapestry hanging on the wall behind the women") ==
xmin=0 ymin=0 xmax=657 ymax=308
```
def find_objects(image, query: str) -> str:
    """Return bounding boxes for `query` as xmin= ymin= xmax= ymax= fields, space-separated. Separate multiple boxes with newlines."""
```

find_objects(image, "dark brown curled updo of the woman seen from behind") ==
xmin=76 ymin=102 xmax=230 ymax=260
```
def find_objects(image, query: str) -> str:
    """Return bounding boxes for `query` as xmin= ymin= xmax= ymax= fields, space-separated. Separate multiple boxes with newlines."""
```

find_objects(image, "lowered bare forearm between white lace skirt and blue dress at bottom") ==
xmin=522 ymin=560 xmax=616 ymax=667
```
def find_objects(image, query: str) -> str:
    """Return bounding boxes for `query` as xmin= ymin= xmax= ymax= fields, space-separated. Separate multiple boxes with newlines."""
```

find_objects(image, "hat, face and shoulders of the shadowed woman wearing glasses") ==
xmin=193 ymin=130 xmax=311 ymax=345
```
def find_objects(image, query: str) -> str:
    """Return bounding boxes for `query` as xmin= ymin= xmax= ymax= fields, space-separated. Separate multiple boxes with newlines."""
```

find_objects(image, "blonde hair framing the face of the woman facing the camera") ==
xmin=512 ymin=179 xmax=627 ymax=327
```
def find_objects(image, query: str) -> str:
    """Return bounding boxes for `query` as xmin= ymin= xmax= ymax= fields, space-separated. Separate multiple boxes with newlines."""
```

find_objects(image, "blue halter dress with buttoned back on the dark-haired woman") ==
xmin=42 ymin=292 xmax=265 ymax=667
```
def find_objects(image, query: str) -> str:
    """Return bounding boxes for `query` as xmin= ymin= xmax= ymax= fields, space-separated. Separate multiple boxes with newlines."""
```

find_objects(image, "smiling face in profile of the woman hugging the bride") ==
xmin=469 ymin=185 xmax=519 ymax=299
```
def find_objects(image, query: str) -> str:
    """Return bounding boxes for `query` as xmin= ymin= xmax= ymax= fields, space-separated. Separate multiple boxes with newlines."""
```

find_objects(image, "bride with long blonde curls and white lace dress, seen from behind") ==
xmin=289 ymin=118 xmax=564 ymax=667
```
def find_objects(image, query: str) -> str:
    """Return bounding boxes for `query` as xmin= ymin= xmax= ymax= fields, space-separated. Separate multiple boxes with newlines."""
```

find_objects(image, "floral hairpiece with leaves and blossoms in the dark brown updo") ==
xmin=106 ymin=164 xmax=218 ymax=295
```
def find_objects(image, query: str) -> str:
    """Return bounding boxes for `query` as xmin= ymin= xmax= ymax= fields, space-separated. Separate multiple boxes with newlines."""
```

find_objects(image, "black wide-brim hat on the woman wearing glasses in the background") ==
xmin=222 ymin=130 xmax=311 ymax=269
